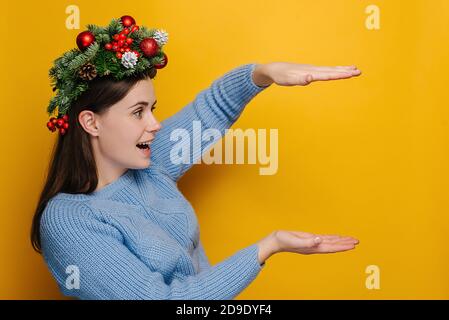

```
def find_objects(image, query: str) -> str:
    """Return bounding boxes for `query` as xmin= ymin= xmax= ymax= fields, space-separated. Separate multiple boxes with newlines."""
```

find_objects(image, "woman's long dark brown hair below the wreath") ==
xmin=31 ymin=68 xmax=157 ymax=253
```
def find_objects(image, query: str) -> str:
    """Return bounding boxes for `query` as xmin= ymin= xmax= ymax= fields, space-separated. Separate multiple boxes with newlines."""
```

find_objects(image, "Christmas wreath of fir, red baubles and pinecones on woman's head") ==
xmin=47 ymin=16 xmax=168 ymax=135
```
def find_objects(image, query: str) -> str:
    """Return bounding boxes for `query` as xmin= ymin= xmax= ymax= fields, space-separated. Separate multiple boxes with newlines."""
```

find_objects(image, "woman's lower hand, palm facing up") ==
xmin=258 ymin=230 xmax=359 ymax=264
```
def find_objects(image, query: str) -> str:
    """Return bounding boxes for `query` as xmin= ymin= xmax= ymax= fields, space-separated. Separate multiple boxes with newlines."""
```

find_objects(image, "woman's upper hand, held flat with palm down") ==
xmin=253 ymin=62 xmax=362 ymax=86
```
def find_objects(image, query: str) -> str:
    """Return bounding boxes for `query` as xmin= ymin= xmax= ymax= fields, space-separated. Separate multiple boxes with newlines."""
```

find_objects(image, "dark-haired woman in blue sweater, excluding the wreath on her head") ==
xmin=31 ymin=17 xmax=360 ymax=299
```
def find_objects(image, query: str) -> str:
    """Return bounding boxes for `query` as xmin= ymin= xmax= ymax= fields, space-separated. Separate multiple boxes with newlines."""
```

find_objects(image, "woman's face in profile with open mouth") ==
xmin=84 ymin=78 xmax=161 ymax=171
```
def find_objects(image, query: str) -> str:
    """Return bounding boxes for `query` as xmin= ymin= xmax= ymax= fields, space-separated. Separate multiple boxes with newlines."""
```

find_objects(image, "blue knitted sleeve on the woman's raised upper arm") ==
xmin=150 ymin=63 xmax=270 ymax=181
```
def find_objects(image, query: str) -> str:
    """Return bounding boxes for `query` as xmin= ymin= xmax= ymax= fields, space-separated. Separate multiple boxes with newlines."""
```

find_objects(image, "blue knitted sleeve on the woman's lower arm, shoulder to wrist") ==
xmin=41 ymin=205 xmax=263 ymax=300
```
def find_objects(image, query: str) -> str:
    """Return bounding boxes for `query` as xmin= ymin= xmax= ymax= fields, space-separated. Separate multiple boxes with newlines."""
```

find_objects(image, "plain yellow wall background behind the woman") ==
xmin=0 ymin=0 xmax=449 ymax=299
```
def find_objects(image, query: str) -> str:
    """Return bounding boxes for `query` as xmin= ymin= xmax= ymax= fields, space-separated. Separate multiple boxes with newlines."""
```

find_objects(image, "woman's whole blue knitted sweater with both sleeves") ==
xmin=40 ymin=63 xmax=269 ymax=300
